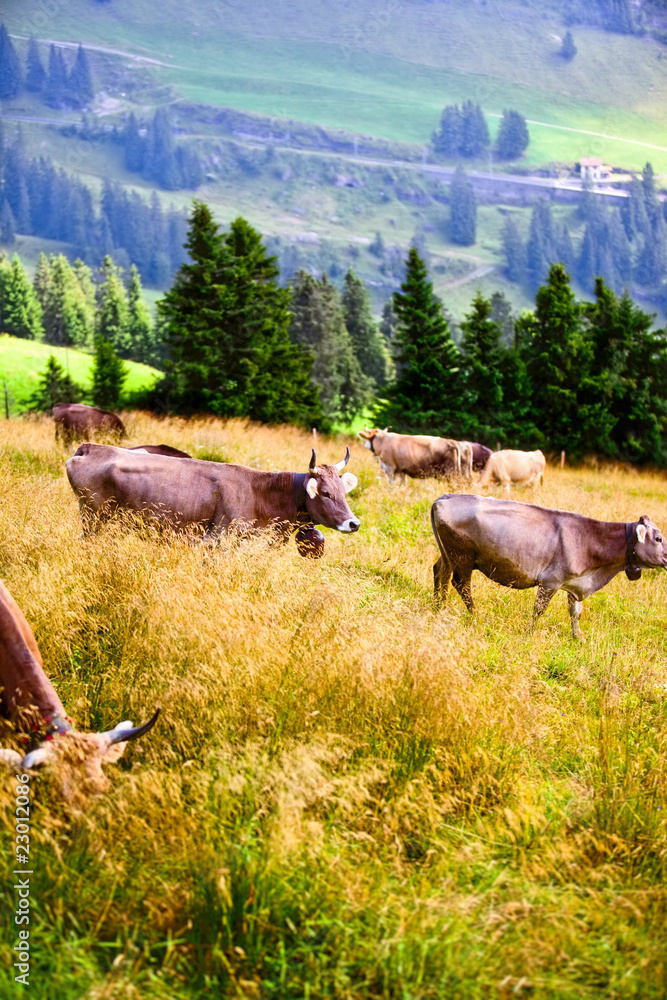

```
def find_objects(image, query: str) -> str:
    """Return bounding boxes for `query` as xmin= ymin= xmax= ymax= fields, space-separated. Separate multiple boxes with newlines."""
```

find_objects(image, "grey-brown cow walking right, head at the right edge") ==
xmin=431 ymin=493 xmax=667 ymax=639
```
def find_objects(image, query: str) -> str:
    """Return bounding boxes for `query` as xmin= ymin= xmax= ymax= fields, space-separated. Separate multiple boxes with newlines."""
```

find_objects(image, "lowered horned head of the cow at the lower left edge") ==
xmin=0 ymin=708 xmax=160 ymax=801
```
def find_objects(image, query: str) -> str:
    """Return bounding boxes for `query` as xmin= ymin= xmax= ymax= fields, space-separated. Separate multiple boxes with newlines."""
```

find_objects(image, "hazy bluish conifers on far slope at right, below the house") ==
xmin=502 ymin=163 xmax=667 ymax=300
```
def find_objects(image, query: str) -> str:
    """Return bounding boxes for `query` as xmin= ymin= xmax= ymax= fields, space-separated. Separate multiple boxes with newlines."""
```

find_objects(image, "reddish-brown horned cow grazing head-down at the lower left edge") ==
xmin=0 ymin=583 xmax=160 ymax=798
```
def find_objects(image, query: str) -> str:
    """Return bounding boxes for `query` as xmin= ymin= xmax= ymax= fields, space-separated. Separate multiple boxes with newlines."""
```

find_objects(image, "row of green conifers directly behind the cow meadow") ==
xmin=5 ymin=202 xmax=667 ymax=465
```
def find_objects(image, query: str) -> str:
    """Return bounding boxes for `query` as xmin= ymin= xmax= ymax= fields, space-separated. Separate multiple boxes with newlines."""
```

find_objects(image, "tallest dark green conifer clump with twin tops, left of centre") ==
xmin=158 ymin=201 xmax=322 ymax=427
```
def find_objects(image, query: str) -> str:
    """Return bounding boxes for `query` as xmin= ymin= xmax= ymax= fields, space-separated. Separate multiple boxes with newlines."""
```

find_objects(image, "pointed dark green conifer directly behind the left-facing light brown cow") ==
xmin=376 ymin=247 xmax=462 ymax=435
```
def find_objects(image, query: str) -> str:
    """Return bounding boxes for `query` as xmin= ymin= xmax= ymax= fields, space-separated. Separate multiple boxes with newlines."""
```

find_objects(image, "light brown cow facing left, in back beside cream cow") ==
xmin=359 ymin=428 xmax=462 ymax=483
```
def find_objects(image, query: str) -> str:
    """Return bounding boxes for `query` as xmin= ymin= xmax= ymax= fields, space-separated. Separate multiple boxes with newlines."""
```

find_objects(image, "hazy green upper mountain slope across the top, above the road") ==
xmin=3 ymin=0 xmax=667 ymax=169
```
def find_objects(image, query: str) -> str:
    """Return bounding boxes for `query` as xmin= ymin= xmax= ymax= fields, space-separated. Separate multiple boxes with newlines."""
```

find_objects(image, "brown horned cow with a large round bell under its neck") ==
xmin=66 ymin=444 xmax=359 ymax=550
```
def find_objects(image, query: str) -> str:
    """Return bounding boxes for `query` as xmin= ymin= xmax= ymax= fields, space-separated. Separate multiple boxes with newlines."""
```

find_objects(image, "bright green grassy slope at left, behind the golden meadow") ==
xmin=0 ymin=333 xmax=160 ymax=415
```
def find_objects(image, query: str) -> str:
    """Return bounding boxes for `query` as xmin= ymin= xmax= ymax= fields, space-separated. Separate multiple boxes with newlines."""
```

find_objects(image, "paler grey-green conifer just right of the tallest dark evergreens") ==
xmin=290 ymin=271 xmax=373 ymax=423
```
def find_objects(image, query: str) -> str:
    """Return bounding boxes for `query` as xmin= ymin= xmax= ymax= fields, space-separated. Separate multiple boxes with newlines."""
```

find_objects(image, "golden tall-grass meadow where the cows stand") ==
xmin=0 ymin=413 xmax=667 ymax=1000
